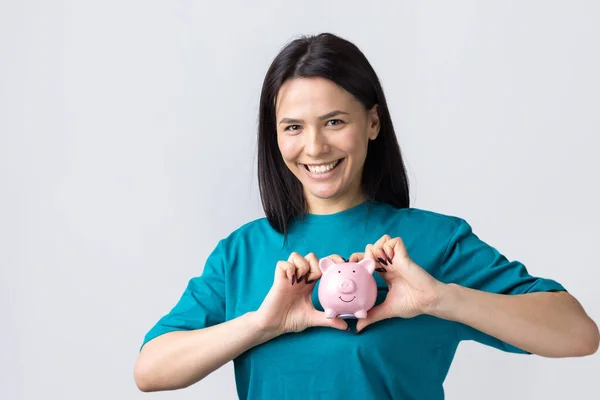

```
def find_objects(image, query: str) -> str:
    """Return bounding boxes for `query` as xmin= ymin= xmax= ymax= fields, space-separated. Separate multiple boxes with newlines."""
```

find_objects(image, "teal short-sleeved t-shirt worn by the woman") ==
xmin=143 ymin=201 xmax=565 ymax=400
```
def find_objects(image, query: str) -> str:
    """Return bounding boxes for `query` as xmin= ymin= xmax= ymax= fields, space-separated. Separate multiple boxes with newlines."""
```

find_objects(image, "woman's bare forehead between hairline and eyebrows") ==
xmin=275 ymin=77 xmax=360 ymax=117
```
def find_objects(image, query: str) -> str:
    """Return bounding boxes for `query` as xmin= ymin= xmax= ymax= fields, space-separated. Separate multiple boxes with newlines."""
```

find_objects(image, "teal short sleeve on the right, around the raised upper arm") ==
xmin=442 ymin=219 xmax=566 ymax=354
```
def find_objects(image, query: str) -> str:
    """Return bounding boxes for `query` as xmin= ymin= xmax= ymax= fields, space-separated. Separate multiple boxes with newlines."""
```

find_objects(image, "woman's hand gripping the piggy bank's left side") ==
xmin=256 ymin=252 xmax=348 ymax=334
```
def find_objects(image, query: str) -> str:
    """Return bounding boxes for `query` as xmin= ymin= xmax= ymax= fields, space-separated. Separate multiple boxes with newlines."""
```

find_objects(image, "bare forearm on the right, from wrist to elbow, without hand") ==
xmin=427 ymin=284 xmax=600 ymax=357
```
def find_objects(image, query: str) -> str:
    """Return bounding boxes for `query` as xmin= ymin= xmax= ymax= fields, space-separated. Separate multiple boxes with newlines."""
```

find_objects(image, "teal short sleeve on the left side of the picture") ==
xmin=142 ymin=242 xmax=226 ymax=347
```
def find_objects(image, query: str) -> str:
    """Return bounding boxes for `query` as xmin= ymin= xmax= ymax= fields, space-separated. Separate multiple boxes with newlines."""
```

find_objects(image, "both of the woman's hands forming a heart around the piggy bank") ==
xmin=257 ymin=235 xmax=444 ymax=334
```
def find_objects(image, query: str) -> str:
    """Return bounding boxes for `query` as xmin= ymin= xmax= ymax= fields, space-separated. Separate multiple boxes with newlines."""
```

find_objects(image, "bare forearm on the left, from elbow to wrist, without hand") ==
xmin=134 ymin=312 xmax=278 ymax=392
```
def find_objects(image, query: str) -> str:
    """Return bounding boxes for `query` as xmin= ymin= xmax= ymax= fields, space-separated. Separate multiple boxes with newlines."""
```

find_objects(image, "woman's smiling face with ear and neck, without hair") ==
xmin=276 ymin=78 xmax=379 ymax=212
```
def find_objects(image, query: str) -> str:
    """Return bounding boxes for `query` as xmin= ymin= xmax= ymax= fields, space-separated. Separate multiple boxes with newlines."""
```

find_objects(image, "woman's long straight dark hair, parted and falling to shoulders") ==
xmin=258 ymin=33 xmax=410 ymax=235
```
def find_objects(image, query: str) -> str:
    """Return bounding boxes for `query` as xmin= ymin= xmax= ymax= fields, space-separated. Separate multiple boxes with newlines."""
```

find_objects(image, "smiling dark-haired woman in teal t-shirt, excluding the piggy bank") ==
xmin=135 ymin=34 xmax=599 ymax=399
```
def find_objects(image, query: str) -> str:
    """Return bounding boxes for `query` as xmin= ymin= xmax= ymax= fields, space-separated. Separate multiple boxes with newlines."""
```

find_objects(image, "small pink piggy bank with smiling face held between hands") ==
xmin=318 ymin=258 xmax=377 ymax=318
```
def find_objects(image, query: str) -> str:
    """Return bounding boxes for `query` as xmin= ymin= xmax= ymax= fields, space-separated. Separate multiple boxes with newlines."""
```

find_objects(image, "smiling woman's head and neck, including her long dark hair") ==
xmin=258 ymin=34 xmax=409 ymax=234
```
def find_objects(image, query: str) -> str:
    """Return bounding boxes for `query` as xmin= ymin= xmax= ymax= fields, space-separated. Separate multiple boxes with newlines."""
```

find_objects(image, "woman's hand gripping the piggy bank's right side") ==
xmin=349 ymin=235 xmax=445 ymax=332
